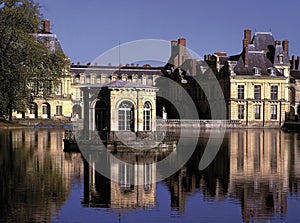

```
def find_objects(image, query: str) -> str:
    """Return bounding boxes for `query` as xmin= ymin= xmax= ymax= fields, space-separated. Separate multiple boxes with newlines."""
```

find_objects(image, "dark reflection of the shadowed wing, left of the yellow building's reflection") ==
xmin=164 ymin=135 xmax=229 ymax=213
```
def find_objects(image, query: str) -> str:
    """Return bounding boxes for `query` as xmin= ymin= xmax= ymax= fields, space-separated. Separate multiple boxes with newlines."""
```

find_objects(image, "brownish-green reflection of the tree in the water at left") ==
xmin=0 ymin=132 xmax=70 ymax=222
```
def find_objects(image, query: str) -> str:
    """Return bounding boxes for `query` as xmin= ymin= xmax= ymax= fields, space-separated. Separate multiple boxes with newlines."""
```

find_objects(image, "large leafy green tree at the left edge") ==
xmin=0 ymin=0 xmax=68 ymax=120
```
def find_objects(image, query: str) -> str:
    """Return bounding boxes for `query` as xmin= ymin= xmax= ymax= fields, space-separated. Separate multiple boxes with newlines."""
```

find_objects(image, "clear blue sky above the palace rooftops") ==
xmin=36 ymin=0 xmax=300 ymax=64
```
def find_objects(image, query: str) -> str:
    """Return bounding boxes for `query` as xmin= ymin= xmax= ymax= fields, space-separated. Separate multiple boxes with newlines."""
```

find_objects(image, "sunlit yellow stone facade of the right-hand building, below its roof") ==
xmin=228 ymin=76 xmax=289 ymax=127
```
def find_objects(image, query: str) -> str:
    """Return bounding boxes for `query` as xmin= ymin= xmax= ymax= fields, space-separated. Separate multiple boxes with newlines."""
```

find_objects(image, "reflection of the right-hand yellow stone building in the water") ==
xmin=229 ymin=130 xmax=289 ymax=222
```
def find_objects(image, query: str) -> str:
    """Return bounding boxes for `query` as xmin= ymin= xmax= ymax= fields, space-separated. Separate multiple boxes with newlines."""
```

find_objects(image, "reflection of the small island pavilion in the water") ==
xmin=84 ymin=152 xmax=156 ymax=209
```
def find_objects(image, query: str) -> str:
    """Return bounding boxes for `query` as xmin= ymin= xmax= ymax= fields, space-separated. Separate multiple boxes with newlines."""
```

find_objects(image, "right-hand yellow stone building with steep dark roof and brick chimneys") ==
xmin=225 ymin=30 xmax=290 ymax=127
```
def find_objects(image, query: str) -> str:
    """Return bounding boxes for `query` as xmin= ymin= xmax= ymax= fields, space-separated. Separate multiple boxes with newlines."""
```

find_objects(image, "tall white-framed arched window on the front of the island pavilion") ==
xmin=119 ymin=101 xmax=133 ymax=131
